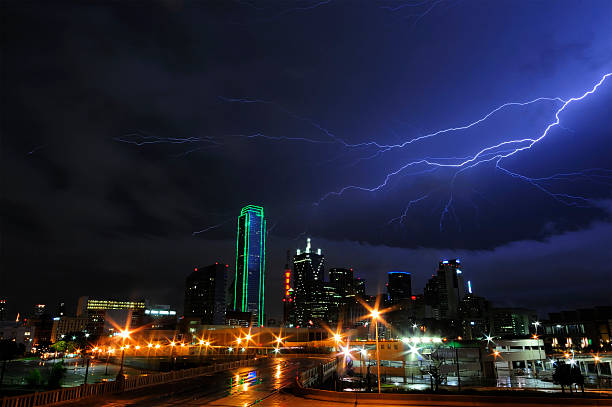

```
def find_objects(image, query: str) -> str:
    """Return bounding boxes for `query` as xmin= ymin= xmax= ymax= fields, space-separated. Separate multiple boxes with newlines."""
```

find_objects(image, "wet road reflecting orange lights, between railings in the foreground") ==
xmin=68 ymin=357 xmax=325 ymax=407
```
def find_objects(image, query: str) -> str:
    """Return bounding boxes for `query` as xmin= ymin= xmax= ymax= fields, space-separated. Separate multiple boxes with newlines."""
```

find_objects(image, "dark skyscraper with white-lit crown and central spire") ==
xmin=293 ymin=238 xmax=325 ymax=326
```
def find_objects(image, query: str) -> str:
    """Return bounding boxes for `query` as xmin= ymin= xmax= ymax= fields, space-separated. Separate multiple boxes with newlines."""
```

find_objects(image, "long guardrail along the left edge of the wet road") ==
xmin=0 ymin=358 xmax=262 ymax=407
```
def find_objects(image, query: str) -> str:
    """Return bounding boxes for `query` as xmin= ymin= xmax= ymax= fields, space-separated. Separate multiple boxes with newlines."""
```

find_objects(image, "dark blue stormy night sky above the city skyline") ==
xmin=0 ymin=0 xmax=612 ymax=317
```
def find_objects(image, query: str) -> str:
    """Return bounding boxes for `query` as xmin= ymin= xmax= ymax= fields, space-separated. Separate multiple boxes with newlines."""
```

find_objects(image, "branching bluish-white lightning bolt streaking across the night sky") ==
xmin=115 ymin=72 xmax=612 ymax=234
